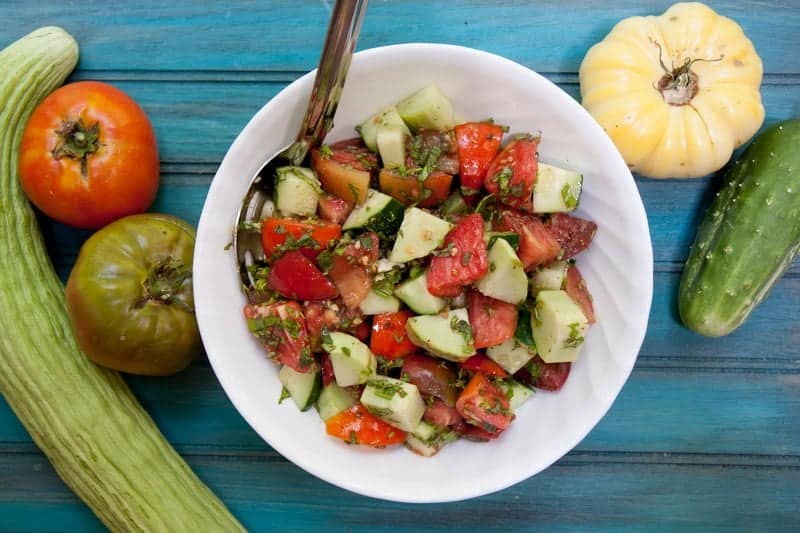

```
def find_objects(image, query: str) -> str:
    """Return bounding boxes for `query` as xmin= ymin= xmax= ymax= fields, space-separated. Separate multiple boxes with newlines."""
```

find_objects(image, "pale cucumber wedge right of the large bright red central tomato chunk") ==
xmin=475 ymin=239 xmax=528 ymax=304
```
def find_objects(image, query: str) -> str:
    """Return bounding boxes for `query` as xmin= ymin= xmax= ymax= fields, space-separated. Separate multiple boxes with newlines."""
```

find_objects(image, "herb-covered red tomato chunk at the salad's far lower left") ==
xmin=244 ymin=301 xmax=316 ymax=372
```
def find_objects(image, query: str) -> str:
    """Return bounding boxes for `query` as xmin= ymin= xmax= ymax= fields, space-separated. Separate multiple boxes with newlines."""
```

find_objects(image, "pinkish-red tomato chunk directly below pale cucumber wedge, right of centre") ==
xmin=467 ymin=290 xmax=519 ymax=348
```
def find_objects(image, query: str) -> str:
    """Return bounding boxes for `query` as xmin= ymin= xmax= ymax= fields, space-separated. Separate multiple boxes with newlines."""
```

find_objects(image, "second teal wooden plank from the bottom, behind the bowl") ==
xmin=0 ymin=365 xmax=800 ymax=461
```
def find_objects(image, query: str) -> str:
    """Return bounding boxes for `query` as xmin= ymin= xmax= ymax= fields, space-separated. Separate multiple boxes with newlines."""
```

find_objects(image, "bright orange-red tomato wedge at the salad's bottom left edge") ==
xmin=325 ymin=403 xmax=406 ymax=448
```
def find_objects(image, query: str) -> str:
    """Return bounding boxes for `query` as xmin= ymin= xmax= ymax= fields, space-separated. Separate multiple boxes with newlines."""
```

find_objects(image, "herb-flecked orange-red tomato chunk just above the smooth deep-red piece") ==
xmin=261 ymin=217 xmax=342 ymax=259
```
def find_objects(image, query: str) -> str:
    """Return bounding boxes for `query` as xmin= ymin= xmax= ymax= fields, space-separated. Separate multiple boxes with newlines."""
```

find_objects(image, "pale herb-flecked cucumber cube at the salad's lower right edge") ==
xmin=531 ymin=291 xmax=589 ymax=363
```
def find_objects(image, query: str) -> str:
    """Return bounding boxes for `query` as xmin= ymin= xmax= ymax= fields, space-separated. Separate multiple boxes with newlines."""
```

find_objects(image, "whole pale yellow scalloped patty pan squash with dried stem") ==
xmin=579 ymin=3 xmax=764 ymax=178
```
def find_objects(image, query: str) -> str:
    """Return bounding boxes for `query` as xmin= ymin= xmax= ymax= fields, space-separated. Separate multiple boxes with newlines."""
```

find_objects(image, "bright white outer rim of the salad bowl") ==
xmin=194 ymin=42 xmax=654 ymax=503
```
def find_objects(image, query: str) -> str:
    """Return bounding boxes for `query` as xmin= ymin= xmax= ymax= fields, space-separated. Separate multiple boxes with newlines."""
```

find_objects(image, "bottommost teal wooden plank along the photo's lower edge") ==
xmin=0 ymin=448 xmax=800 ymax=532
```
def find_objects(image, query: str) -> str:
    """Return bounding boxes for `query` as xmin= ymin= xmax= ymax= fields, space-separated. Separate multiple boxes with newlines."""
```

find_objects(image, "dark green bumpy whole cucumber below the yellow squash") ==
xmin=678 ymin=119 xmax=800 ymax=337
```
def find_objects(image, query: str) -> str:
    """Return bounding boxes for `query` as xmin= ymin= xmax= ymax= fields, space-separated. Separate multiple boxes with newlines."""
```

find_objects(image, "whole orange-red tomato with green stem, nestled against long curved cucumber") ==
xmin=19 ymin=81 xmax=159 ymax=229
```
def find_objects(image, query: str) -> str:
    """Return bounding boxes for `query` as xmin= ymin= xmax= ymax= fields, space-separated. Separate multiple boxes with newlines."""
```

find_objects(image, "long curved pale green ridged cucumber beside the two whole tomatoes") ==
xmin=0 ymin=27 xmax=243 ymax=531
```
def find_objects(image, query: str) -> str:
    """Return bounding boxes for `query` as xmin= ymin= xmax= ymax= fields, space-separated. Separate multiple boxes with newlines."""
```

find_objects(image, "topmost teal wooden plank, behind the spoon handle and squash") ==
xmin=0 ymin=0 xmax=800 ymax=74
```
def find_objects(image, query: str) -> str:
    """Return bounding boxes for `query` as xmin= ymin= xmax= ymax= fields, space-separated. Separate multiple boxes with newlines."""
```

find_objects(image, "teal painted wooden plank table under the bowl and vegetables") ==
xmin=0 ymin=0 xmax=800 ymax=531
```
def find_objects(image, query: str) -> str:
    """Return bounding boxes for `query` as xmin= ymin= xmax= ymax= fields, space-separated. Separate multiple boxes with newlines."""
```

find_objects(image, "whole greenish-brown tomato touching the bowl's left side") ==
xmin=66 ymin=213 xmax=200 ymax=375
